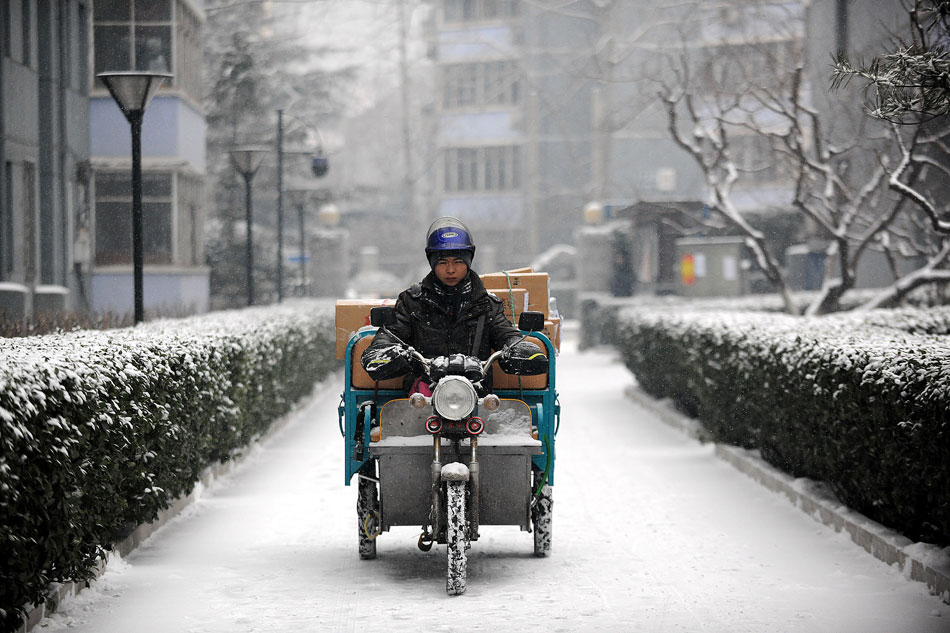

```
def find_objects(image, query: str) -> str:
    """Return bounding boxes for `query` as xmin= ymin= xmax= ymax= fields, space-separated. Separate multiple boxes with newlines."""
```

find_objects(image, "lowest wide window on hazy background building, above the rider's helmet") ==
xmin=443 ymin=145 xmax=521 ymax=192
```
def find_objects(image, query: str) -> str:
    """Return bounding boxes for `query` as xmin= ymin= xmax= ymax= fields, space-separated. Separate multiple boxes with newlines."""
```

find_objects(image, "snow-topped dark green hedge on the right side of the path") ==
xmin=612 ymin=307 xmax=950 ymax=545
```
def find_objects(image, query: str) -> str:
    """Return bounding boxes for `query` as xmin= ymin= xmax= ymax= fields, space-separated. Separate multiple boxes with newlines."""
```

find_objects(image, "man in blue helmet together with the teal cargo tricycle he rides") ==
xmin=339 ymin=218 xmax=560 ymax=594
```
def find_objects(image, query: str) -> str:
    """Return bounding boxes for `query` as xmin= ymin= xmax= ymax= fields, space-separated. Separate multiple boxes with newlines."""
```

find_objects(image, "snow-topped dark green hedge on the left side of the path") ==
xmin=0 ymin=301 xmax=338 ymax=630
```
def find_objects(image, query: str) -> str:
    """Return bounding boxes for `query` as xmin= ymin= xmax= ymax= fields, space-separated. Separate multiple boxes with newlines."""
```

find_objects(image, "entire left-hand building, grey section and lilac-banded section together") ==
xmin=0 ymin=0 xmax=209 ymax=315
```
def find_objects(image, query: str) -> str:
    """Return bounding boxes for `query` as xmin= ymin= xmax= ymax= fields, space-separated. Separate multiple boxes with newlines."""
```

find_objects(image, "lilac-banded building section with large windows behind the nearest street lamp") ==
xmin=89 ymin=0 xmax=210 ymax=314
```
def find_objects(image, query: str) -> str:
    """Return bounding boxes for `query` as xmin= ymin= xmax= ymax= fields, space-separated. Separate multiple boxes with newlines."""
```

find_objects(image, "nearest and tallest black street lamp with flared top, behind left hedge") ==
xmin=96 ymin=71 xmax=172 ymax=323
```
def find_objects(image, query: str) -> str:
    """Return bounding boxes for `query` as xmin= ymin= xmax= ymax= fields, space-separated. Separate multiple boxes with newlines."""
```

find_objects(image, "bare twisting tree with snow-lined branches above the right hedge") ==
xmin=660 ymin=1 xmax=950 ymax=314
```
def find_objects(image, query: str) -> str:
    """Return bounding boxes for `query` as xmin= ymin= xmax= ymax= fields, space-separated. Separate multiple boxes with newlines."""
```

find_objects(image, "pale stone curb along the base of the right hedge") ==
xmin=624 ymin=387 xmax=950 ymax=604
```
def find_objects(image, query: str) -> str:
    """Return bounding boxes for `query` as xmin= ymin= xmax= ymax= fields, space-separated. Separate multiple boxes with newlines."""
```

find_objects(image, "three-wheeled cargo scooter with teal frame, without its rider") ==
xmin=338 ymin=307 xmax=560 ymax=594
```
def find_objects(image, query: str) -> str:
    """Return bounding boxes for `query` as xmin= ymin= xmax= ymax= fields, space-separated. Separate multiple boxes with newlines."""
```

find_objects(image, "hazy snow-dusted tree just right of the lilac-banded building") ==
xmin=204 ymin=0 xmax=353 ymax=306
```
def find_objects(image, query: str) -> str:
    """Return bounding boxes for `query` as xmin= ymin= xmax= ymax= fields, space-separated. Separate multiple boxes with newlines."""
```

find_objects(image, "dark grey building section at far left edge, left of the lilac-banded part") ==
xmin=0 ymin=0 xmax=92 ymax=313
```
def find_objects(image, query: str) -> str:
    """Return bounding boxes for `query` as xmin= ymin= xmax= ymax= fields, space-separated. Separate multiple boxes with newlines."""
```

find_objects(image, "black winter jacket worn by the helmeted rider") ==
xmin=361 ymin=270 xmax=521 ymax=380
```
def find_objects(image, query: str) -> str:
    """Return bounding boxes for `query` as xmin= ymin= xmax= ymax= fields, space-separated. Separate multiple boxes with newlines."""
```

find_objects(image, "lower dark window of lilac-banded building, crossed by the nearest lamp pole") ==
xmin=96 ymin=172 xmax=173 ymax=266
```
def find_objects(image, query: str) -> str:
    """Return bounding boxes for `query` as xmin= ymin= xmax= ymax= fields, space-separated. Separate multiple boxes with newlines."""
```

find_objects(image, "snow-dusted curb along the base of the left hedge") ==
xmin=16 ymin=396 xmax=304 ymax=633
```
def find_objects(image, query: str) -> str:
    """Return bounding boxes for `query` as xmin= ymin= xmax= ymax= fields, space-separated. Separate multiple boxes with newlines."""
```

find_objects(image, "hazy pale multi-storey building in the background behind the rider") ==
xmin=430 ymin=0 xmax=804 ymax=267
